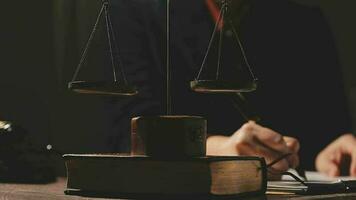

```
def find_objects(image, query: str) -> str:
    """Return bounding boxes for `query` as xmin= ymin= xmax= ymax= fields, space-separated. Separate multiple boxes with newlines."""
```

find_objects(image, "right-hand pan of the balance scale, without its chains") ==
xmin=190 ymin=80 xmax=257 ymax=93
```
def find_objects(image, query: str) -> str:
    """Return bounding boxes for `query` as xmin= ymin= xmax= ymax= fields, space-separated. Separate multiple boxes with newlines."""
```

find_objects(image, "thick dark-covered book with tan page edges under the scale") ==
xmin=64 ymin=154 xmax=267 ymax=197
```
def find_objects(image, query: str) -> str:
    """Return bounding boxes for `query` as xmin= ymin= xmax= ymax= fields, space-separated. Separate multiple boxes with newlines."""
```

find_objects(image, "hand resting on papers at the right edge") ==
xmin=315 ymin=134 xmax=356 ymax=176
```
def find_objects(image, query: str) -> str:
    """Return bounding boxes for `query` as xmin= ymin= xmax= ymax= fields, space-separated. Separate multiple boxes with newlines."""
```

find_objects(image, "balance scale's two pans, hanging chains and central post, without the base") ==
xmin=68 ymin=0 xmax=257 ymax=115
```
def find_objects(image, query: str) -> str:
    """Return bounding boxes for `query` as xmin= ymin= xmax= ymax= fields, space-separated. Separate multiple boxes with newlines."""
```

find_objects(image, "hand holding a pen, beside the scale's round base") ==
xmin=207 ymin=121 xmax=299 ymax=172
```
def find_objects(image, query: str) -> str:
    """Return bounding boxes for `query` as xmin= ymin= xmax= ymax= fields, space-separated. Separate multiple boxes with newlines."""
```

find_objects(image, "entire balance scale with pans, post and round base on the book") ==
xmin=64 ymin=0 xmax=266 ymax=197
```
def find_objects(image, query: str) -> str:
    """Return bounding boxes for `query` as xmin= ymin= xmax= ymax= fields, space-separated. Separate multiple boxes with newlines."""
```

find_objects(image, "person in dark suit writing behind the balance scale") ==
xmin=111 ymin=0 xmax=351 ymax=175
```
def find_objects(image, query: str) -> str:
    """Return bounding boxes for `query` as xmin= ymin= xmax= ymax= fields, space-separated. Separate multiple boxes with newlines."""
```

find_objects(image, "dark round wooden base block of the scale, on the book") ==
xmin=131 ymin=116 xmax=207 ymax=159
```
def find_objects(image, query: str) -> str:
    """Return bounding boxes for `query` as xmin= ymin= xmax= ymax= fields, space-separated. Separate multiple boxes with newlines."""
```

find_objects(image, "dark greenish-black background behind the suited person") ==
xmin=0 ymin=0 xmax=356 ymax=172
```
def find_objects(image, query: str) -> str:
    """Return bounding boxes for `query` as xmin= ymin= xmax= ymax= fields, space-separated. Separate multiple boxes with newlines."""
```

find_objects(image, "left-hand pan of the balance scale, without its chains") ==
xmin=68 ymin=81 xmax=138 ymax=96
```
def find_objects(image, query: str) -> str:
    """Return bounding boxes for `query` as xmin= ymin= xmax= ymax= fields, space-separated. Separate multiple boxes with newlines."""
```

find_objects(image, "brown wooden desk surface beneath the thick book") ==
xmin=0 ymin=178 xmax=356 ymax=200
